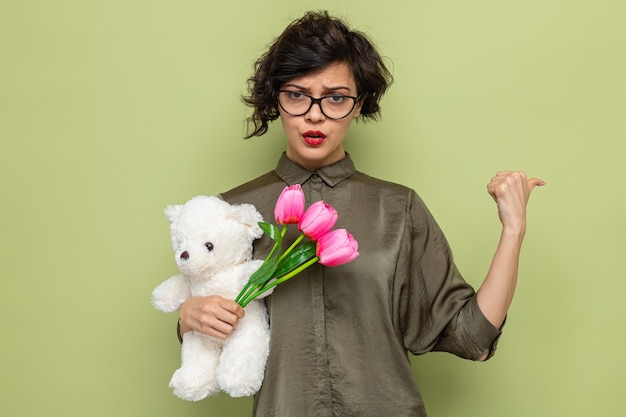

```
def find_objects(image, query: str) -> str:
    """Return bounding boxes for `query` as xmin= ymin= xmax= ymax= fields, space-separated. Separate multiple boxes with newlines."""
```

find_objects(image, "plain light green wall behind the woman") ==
xmin=0 ymin=0 xmax=626 ymax=417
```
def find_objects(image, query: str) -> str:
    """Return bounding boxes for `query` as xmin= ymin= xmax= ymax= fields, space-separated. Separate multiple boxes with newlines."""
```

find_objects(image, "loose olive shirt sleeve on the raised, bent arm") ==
xmin=395 ymin=191 xmax=501 ymax=360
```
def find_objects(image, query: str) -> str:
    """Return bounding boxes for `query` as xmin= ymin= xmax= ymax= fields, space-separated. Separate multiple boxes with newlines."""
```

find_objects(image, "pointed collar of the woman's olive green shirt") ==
xmin=276 ymin=152 xmax=356 ymax=187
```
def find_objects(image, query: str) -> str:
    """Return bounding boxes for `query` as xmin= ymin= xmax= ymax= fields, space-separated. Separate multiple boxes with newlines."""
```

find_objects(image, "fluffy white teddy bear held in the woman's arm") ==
xmin=152 ymin=196 xmax=270 ymax=401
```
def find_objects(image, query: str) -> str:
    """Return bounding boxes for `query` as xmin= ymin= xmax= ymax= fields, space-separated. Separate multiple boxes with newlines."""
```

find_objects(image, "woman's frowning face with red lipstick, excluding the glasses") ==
xmin=278 ymin=63 xmax=361 ymax=171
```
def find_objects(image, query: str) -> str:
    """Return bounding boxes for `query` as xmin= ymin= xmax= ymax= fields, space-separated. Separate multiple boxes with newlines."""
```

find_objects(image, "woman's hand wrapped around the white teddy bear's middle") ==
xmin=180 ymin=295 xmax=244 ymax=339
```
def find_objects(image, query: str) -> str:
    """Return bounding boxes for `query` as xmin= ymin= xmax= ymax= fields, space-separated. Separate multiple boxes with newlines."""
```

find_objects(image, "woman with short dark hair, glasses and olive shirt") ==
xmin=180 ymin=13 xmax=543 ymax=417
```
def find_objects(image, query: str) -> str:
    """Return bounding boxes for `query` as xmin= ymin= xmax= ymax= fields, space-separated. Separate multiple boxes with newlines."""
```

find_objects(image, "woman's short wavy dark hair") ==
xmin=243 ymin=11 xmax=393 ymax=139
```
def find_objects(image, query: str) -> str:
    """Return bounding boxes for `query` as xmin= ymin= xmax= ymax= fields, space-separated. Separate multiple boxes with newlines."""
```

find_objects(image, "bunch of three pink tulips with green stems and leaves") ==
xmin=235 ymin=184 xmax=359 ymax=307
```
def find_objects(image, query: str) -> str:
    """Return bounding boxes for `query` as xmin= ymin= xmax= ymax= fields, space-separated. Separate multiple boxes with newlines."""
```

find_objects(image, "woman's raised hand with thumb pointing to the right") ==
xmin=487 ymin=171 xmax=545 ymax=233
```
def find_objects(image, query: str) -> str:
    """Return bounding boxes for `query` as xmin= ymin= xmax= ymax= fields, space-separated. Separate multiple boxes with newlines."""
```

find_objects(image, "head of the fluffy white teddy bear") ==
xmin=165 ymin=196 xmax=263 ymax=278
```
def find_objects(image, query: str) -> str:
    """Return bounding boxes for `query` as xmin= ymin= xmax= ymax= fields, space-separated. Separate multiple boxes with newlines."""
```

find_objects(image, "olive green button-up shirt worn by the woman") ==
xmin=222 ymin=154 xmax=500 ymax=417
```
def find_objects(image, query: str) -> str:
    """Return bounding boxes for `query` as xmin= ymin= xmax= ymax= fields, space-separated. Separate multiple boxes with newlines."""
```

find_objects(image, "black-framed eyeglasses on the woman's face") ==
xmin=278 ymin=90 xmax=360 ymax=120
